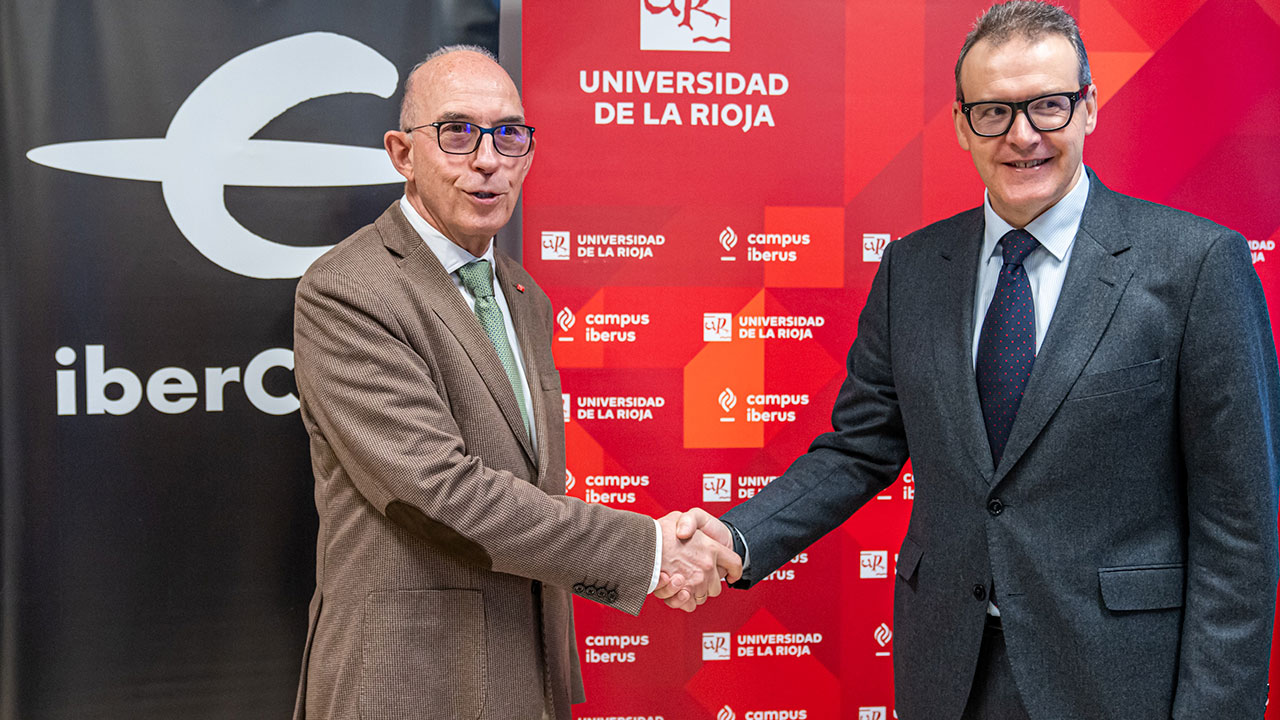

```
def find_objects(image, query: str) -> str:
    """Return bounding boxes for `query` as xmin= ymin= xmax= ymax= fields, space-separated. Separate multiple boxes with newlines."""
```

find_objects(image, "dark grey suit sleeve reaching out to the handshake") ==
xmin=724 ymin=241 xmax=908 ymax=588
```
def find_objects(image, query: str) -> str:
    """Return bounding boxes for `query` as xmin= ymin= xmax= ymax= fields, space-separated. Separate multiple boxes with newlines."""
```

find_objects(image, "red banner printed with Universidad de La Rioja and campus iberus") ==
xmin=522 ymin=0 xmax=1280 ymax=720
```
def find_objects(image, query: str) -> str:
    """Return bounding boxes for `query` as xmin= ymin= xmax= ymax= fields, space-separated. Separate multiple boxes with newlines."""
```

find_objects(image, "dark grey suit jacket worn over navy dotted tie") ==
xmin=724 ymin=173 xmax=1280 ymax=720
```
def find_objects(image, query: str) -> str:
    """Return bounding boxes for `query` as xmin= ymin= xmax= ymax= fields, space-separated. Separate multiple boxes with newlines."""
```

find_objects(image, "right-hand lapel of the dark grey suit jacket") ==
xmin=995 ymin=173 xmax=1133 ymax=482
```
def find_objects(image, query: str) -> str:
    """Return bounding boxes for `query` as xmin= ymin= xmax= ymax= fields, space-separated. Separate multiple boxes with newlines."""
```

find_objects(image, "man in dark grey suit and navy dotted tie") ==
xmin=659 ymin=3 xmax=1280 ymax=720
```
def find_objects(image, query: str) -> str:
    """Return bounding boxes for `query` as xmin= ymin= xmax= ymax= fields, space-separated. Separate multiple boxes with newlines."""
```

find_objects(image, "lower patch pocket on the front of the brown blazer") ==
xmin=360 ymin=589 xmax=489 ymax=720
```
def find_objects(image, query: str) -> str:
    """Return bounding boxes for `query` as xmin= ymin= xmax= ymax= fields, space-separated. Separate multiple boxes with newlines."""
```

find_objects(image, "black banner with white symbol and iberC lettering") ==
xmin=0 ymin=0 xmax=498 ymax=720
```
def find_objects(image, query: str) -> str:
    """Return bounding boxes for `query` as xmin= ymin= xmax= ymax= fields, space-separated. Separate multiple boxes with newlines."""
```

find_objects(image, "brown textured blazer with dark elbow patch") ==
xmin=293 ymin=204 xmax=655 ymax=720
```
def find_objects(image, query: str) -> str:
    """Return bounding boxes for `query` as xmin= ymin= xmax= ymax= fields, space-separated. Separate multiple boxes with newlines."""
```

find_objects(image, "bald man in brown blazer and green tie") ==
xmin=294 ymin=47 xmax=741 ymax=720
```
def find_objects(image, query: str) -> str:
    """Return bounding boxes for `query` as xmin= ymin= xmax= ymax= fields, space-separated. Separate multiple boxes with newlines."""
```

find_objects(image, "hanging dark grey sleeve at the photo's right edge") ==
xmin=1174 ymin=228 xmax=1280 ymax=719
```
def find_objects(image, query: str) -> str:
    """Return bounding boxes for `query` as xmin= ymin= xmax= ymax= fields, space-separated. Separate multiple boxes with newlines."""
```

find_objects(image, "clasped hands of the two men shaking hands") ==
xmin=653 ymin=507 xmax=742 ymax=612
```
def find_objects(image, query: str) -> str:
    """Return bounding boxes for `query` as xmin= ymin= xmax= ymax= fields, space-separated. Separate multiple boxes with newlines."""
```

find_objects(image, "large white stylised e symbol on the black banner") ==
xmin=27 ymin=32 xmax=404 ymax=278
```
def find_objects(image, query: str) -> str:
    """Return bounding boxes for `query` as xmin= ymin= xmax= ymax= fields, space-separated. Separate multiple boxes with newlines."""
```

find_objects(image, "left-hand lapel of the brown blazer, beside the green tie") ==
xmin=378 ymin=202 xmax=538 ymax=462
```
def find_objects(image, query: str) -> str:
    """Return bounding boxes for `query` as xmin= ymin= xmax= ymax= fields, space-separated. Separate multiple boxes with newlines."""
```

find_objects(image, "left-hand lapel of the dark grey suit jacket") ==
xmin=932 ymin=208 xmax=995 ymax=483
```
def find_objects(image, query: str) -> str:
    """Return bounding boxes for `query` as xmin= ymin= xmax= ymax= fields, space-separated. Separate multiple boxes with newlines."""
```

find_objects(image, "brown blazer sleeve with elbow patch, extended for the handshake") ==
xmin=294 ymin=270 xmax=658 ymax=614
